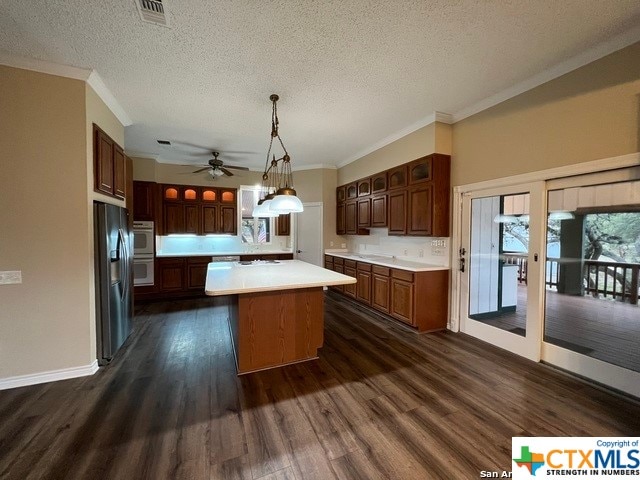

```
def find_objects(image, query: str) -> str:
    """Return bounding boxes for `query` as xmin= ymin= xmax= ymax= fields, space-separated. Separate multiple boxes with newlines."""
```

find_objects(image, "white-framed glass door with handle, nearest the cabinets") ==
xmin=458 ymin=182 xmax=544 ymax=361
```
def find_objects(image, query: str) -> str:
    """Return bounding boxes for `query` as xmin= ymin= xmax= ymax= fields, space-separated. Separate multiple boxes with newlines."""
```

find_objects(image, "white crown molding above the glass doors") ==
xmin=452 ymin=26 xmax=640 ymax=123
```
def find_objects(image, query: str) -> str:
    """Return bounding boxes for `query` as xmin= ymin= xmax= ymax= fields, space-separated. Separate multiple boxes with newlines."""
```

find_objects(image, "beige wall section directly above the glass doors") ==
xmin=451 ymin=43 xmax=640 ymax=185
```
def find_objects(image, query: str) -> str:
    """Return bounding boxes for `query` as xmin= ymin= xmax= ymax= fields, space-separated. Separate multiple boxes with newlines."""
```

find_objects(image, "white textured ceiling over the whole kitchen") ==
xmin=0 ymin=0 xmax=640 ymax=170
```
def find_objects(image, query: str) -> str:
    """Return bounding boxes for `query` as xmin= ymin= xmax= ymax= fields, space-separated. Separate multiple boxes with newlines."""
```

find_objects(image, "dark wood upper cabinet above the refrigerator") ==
xmin=93 ymin=123 xmax=127 ymax=199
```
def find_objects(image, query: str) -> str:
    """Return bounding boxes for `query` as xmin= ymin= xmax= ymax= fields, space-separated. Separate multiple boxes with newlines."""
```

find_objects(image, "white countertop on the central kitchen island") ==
xmin=204 ymin=260 xmax=356 ymax=295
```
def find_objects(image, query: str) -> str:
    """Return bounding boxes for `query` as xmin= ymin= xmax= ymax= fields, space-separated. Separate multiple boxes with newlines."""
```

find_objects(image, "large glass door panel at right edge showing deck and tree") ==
xmin=541 ymin=172 xmax=640 ymax=397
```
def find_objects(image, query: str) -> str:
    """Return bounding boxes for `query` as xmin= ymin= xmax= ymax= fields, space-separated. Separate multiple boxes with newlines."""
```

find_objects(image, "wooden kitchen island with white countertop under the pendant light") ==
xmin=205 ymin=260 xmax=356 ymax=374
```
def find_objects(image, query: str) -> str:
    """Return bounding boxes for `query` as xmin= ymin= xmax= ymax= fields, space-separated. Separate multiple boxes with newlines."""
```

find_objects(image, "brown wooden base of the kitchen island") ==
xmin=226 ymin=287 xmax=324 ymax=375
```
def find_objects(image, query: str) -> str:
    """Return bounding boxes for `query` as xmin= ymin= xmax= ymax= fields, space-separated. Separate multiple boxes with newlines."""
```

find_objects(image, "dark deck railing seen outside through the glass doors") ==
xmin=502 ymin=253 xmax=640 ymax=305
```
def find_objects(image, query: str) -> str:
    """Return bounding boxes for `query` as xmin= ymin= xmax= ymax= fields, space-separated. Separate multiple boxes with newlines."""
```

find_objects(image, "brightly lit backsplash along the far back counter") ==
xmin=156 ymin=235 xmax=291 ymax=255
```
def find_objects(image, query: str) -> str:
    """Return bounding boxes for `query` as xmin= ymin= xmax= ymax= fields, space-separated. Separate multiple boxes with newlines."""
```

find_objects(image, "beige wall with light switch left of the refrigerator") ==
xmin=0 ymin=66 xmax=95 ymax=379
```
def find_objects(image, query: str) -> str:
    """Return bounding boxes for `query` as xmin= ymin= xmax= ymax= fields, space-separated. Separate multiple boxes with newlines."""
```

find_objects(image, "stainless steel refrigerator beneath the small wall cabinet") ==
xmin=93 ymin=202 xmax=133 ymax=365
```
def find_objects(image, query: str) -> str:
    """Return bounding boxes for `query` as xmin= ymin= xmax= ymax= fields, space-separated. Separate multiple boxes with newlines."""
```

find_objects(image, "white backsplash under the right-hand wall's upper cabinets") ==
xmin=347 ymin=228 xmax=451 ymax=267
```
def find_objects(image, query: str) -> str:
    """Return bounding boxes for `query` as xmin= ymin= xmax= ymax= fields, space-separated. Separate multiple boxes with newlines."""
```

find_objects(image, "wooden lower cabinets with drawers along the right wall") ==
xmin=325 ymin=254 xmax=449 ymax=332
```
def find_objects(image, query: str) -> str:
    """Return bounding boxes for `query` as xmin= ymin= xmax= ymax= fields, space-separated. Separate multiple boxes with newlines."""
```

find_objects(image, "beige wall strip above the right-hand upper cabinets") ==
xmin=337 ymin=122 xmax=451 ymax=185
